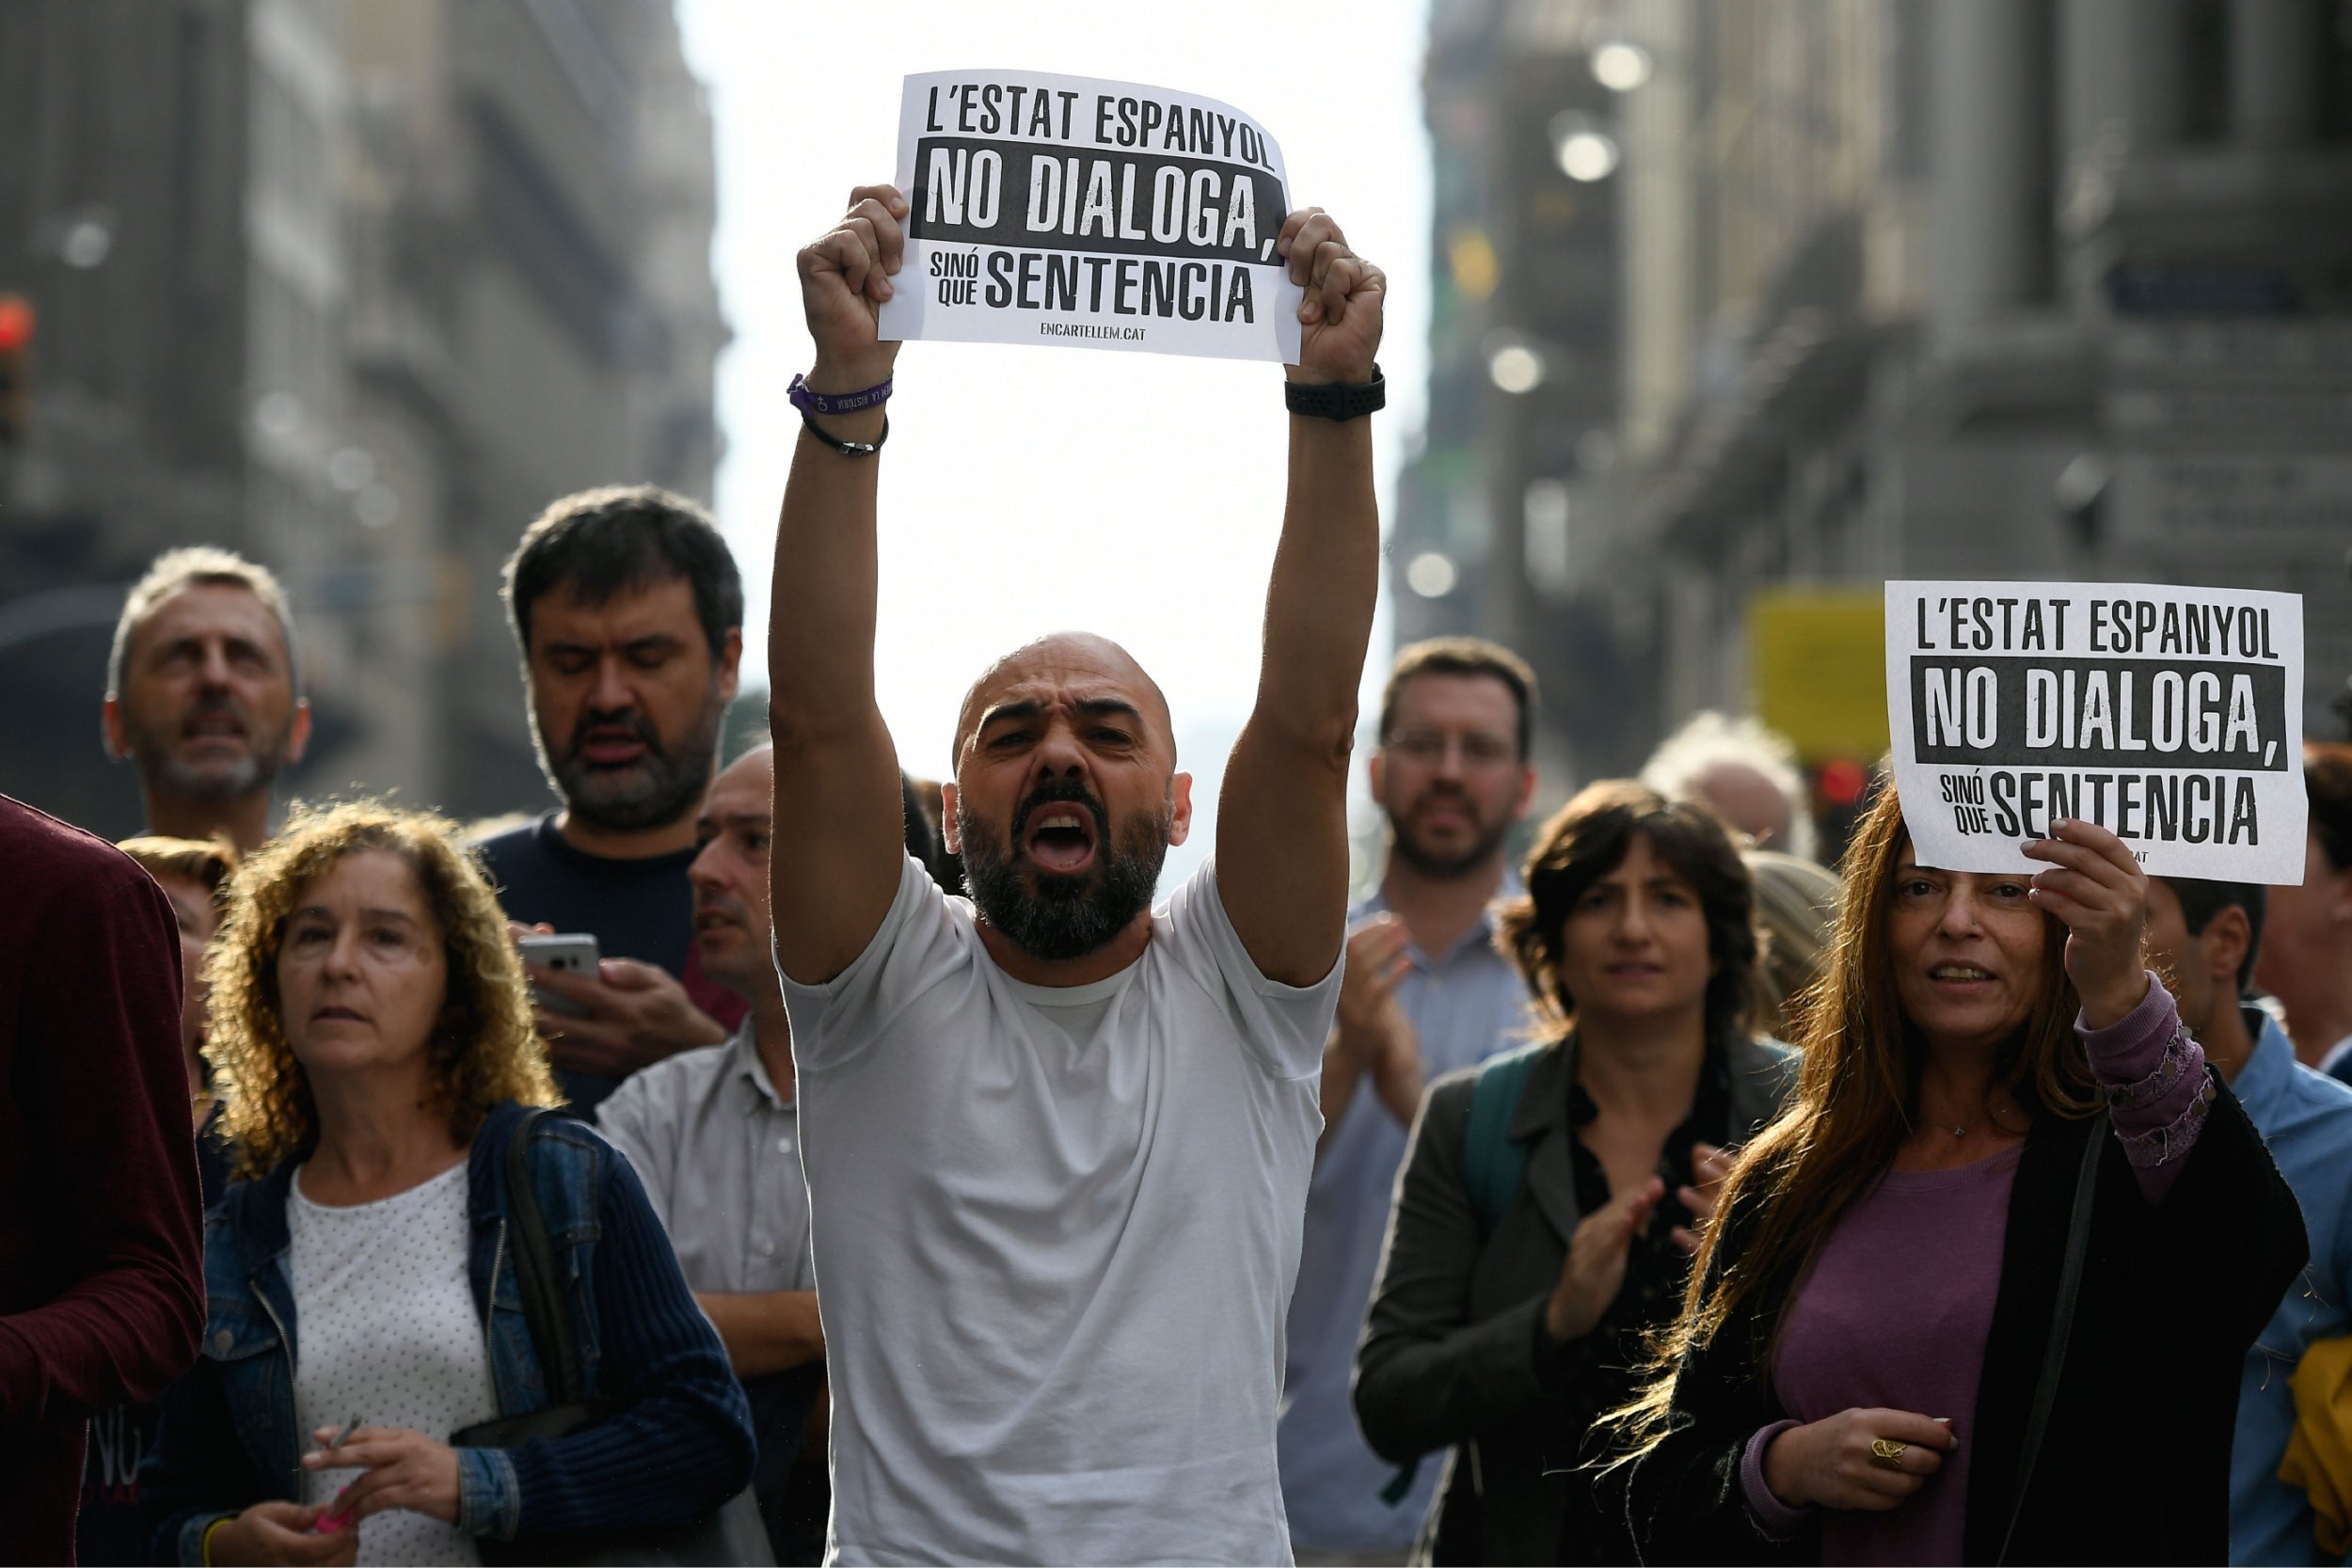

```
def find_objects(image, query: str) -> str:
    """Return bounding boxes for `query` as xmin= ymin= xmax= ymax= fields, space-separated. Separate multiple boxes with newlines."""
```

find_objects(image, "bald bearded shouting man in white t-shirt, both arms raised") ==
xmin=770 ymin=185 xmax=1383 ymax=1563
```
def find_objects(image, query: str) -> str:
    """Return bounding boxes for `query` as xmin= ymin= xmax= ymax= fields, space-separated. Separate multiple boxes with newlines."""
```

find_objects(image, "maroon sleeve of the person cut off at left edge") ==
xmin=0 ymin=822 xmax=205 ymax=1425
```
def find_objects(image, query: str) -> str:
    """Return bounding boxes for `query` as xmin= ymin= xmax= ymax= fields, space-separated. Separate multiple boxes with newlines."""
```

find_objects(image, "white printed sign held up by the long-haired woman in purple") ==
xmin=1886 ymin=583 xmax=2305 ymax=884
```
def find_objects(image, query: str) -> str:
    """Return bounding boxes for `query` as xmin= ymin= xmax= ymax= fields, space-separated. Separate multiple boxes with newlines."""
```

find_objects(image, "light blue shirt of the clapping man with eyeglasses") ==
xmin=1278 ymin=877 xmax=1529 ymax=1552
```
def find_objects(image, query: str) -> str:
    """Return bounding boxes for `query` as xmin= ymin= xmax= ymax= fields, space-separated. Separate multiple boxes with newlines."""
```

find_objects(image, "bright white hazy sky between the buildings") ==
xmin=680 ymin=0 xmax=1430 ymax=872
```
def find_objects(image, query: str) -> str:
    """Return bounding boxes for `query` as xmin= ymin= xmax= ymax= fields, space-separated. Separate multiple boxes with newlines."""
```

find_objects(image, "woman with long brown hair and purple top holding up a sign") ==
xmin=1604 ymin=790 xmax=2305 ymax=1563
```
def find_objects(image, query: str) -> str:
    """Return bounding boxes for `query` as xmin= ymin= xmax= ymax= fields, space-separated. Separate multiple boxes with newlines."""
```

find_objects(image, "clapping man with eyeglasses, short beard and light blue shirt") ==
xmin=1279 ymin=637 xmax=1536 ymax=1563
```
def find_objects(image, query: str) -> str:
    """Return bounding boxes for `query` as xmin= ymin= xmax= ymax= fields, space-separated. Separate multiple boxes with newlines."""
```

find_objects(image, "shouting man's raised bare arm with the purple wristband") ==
xmin=767 ymin=185 xmax=906 ymax=985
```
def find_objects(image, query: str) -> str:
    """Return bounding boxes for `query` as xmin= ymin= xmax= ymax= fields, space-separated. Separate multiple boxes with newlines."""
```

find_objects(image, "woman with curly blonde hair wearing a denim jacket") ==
xmin=141 ymin=804 xmax=753 ymax=1563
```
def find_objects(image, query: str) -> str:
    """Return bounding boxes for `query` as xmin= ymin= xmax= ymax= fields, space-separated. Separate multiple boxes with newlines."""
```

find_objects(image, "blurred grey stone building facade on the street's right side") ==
xmin=1395 ymin=0 xmax=2352 ymax=808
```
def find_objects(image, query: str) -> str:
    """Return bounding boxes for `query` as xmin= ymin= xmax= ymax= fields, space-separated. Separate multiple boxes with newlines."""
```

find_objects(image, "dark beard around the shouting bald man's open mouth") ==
xmin=955 ymin=783 xmax=1169 ymax=964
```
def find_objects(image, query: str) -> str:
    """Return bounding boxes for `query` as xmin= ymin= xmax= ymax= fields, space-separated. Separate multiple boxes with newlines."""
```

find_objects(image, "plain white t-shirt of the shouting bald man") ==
xmin=786 ymin=861 xmax=1339 ymax=1563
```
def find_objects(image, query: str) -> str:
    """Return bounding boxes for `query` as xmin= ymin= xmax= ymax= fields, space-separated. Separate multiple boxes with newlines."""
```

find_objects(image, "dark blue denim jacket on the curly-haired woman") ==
xmin=139 ymin=1105 xmax=753 ymax=1563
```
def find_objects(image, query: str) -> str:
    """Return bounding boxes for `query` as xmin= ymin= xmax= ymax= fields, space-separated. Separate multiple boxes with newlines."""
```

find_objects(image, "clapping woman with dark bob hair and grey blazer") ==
xmin=1355 ymin=783 xmax=1788 ymax=1563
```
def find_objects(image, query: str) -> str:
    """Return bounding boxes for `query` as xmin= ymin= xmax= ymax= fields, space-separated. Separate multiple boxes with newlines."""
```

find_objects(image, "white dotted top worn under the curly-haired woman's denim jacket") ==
xmin=287 ymin=1162 xmax=499 ymax=1563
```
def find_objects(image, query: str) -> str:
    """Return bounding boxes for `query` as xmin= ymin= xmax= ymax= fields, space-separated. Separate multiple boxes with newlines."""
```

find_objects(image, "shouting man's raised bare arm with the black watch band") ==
xmin=1216 ymin=207 xmax=1386 ymax=985
